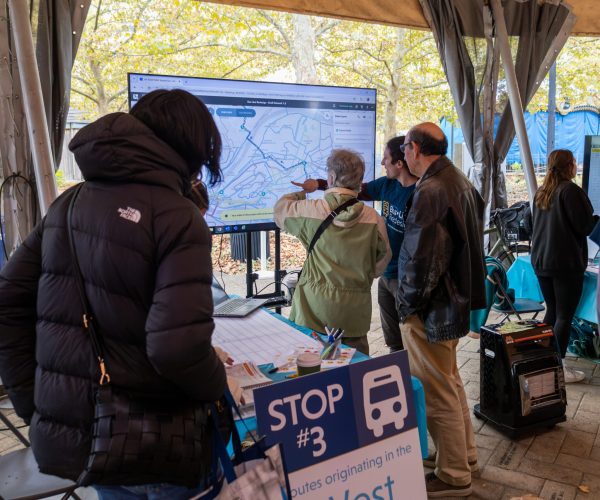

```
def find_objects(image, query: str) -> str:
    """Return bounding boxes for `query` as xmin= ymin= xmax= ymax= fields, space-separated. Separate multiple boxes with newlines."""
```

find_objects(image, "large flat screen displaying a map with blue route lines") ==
xmin=128 ymin=73 xmax=377 ymax=233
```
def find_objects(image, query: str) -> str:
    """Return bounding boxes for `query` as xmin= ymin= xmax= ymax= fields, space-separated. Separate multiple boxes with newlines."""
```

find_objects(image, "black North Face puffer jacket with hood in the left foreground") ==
xmin=0 ymin=113 xmax=226 ymax=479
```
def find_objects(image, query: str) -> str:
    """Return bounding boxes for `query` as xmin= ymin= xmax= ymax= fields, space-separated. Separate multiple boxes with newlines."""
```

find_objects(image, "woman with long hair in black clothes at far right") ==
xmin=531 ymin=149 xmax=598 ymax=382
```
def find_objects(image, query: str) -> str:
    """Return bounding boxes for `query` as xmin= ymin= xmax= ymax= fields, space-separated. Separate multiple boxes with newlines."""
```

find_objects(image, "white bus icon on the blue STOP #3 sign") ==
xmin=363 ymin=365 xmax=408 ymax=437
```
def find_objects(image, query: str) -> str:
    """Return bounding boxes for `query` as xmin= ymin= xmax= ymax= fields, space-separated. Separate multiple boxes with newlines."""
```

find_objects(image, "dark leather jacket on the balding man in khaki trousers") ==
xmin=397 ymin=156 xmax=485 ymax=342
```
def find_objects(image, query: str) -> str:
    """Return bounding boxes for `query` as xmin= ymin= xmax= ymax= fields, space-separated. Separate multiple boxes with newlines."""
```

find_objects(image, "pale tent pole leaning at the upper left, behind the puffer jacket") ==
xmin=8 ymin=0 xmax=58 ymax=213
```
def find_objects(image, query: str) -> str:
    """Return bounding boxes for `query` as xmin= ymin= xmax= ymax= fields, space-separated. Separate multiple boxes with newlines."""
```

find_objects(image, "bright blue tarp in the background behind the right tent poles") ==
xmin=440 ymin=109 xmax=600 ymax=166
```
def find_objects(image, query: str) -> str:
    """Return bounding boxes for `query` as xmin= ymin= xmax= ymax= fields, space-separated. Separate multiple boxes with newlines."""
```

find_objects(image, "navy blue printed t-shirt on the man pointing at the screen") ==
xmin=363 ymin=177 xmax=415 ymax=279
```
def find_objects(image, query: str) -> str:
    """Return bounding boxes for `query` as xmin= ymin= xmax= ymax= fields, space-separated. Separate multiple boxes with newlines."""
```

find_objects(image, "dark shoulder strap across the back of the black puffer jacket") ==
xmin=67 ymin=182 xmax=110 ymax=385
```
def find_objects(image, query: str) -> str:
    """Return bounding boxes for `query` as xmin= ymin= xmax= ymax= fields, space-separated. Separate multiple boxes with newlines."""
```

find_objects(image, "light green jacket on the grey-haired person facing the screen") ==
xmin=274 ymin=188 xmax=392 ymax=337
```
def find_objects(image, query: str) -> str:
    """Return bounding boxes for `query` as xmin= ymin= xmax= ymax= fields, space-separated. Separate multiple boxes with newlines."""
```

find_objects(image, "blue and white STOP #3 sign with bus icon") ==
xmin=254 ymin=351 xmax=427 ymax=500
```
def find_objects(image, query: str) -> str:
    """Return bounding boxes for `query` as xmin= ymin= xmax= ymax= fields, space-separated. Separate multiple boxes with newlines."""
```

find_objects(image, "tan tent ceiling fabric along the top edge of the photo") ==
xmin=204 ymin=0 xmax=600 ymax=36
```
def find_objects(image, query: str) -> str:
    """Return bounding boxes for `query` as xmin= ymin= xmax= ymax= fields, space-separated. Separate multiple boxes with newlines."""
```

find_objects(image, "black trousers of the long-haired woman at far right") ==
xmin=538 ymin=273 xmax=583 ymax=358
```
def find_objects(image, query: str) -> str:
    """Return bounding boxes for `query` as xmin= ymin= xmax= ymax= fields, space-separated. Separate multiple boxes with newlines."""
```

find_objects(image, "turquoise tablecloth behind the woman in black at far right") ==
xmin=506 ymin=255 xmax=598 ymax=323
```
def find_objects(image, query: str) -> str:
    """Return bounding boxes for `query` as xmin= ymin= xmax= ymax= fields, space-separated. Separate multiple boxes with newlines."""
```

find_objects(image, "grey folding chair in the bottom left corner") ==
xmin=0 ymin=397 xmax=79 ymax=500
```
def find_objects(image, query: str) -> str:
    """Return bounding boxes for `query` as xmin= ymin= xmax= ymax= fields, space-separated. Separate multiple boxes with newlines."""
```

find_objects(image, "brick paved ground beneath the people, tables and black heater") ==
xmin=0 ymin=276 xmax=600 ymax=500
